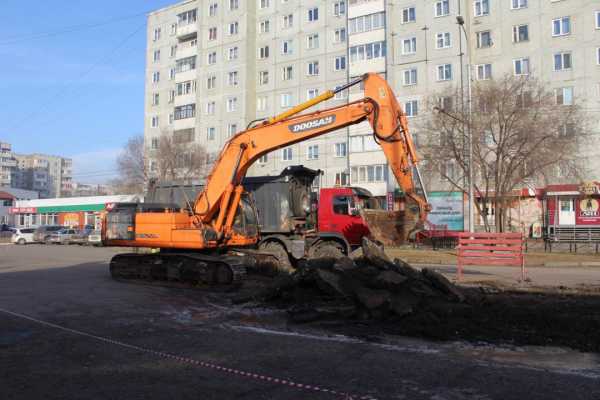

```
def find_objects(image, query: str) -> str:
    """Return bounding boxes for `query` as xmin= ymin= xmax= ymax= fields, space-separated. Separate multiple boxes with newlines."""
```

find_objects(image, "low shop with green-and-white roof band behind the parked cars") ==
xmin=10 ymin=195 xmax=141 ymax=229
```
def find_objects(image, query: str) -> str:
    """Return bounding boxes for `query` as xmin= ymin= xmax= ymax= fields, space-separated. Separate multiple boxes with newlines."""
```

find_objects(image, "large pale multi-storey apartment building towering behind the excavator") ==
xmin=145 ymin=0 xmax=600 ymax=196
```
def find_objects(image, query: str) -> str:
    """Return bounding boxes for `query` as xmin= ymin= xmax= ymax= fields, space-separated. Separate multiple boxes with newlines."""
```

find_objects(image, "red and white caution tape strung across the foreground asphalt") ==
xmin=0 ymin=308 xmax=377 ymax=400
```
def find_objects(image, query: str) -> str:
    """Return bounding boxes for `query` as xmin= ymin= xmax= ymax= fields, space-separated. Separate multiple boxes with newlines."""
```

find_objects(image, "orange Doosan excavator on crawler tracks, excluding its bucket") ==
xmin=102 ymin=73 xmax=430 ymax=284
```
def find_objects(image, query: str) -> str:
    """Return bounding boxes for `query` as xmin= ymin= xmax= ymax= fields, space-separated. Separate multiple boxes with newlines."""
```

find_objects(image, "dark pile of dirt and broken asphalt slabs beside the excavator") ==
xmin=246 ymin=239 xmax=465 ymax=322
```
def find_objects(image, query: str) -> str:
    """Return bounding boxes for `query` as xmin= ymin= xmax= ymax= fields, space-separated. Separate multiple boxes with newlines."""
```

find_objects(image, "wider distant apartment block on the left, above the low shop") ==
xmin=12 ymin=154 xmax=73 ymax=198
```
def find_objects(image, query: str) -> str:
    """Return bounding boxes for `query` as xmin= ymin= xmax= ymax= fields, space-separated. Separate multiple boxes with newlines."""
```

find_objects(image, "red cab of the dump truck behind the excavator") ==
xmin=317 ymin=187 xmax=375 ymax=247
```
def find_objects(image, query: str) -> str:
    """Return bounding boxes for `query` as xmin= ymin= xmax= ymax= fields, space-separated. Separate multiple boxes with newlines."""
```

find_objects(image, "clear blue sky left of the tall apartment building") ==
xmin=0 ymin=0 xmax=175 ymax=183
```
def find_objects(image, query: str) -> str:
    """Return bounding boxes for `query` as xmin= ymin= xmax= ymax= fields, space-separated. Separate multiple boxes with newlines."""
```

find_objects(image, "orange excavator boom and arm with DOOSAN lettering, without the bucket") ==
xmin=194 ymin=73 xmax=429 ymax=242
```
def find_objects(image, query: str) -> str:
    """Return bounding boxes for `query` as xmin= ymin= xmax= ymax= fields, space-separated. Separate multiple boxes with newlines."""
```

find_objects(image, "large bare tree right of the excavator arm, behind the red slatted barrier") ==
xmin=421 ymin=76 xmax=585 ymax=231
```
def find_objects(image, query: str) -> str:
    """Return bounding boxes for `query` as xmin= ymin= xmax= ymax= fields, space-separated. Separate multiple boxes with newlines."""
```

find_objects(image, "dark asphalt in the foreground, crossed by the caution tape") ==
xmin=0 ymin=245 xmax=600 ymax=400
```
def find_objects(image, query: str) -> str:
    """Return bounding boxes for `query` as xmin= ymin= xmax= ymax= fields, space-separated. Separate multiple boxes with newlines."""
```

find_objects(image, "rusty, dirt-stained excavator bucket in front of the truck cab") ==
xmin=360 ymin=196 xmax=422 ymax=246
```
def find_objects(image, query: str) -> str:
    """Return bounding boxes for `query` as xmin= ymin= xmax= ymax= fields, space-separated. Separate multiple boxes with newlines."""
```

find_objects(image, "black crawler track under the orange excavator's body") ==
xmin=110 ymin=253 xmax=247 ymax=287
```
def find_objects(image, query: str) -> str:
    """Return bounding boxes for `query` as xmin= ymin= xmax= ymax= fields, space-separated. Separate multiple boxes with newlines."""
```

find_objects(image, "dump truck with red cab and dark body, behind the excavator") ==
xmin=146 ymin=166 xmax=394 ymax=266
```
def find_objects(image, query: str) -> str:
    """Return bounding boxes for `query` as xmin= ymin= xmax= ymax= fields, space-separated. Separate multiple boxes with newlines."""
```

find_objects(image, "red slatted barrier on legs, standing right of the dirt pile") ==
xmin=457 ymin=232 xmax=525 ymax=280
